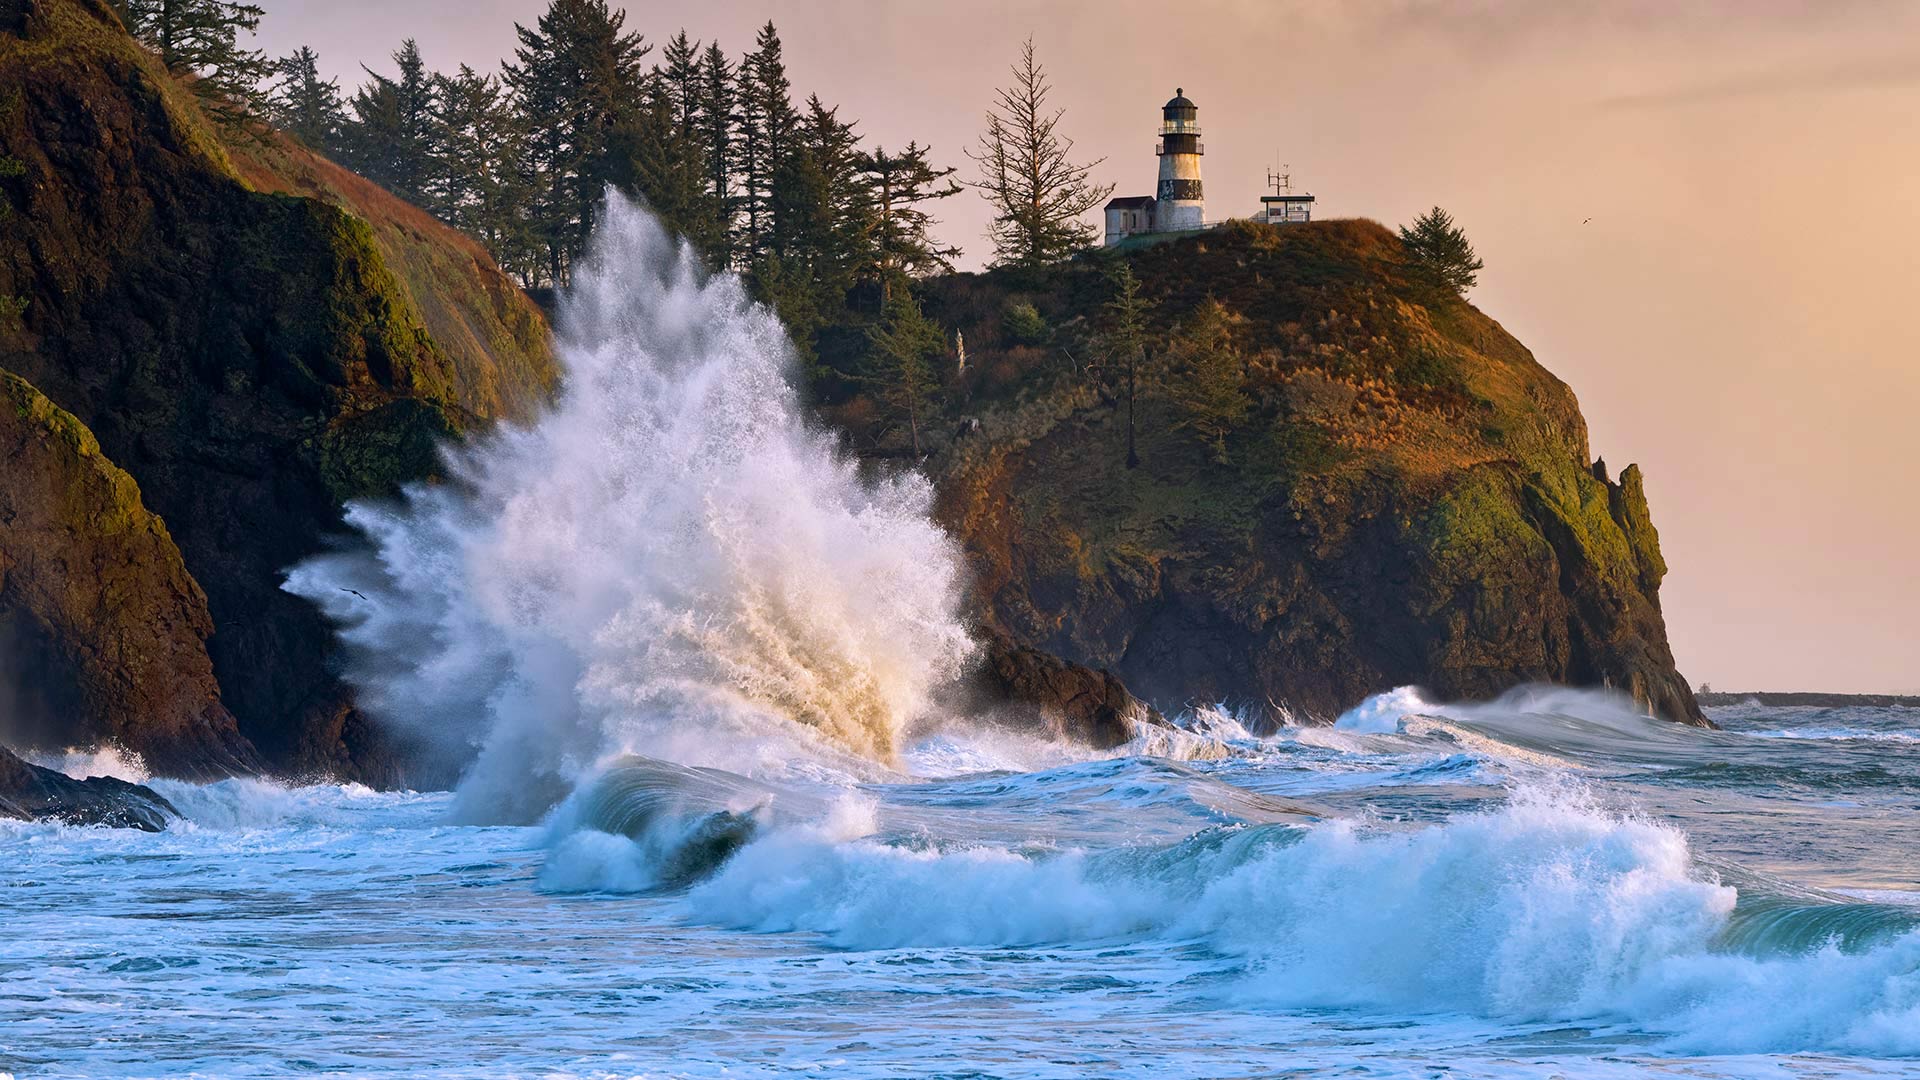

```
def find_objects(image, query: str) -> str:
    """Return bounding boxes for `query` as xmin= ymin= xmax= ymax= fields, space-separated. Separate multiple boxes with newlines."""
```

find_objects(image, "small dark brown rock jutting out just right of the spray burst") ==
xmin=972 ymin=632 xmax=1162 ymax=749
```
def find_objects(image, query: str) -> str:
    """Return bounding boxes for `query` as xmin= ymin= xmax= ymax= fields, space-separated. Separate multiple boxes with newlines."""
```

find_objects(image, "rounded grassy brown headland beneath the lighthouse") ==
xmin=828 ymin=221 xmax=1705 ymax=723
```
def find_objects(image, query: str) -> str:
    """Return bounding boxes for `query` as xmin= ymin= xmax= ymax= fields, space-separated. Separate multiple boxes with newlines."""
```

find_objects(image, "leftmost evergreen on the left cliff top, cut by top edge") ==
xmin=113 ymin=0 xmax=271 ymax=123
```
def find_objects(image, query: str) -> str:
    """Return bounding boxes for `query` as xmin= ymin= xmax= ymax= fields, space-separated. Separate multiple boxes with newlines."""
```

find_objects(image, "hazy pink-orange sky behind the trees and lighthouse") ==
xmin=261 ymin=0 xmax=1920 ymax=692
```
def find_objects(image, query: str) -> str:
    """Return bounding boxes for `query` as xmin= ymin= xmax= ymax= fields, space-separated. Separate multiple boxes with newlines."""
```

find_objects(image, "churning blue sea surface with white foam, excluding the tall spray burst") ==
xmin=0 ymin=692 xmax=1920 ymax=1078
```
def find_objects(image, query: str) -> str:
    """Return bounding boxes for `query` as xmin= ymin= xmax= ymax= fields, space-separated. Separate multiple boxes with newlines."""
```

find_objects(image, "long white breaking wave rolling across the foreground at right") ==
xmin=543 ymin=768 xmax=1920 ymax=1055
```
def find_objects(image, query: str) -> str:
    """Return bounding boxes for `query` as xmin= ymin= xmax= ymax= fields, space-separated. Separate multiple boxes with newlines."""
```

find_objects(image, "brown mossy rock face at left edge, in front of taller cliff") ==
xmin=0 ymin=371 xmax=259 ymax=778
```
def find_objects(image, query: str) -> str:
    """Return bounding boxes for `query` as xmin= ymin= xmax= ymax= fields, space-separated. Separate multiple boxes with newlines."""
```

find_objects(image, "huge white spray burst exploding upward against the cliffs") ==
xmin=286 ymin=196 xmax=972 ymax=821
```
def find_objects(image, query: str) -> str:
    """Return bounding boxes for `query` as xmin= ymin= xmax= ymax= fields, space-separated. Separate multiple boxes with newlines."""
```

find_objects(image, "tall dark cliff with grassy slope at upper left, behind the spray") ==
xmin=0 ymin=0 xmax=553 ymax=782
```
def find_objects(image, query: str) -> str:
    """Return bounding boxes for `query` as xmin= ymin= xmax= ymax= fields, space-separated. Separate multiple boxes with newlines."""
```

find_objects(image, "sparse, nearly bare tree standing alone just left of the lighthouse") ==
xmin=968 ymin=38 xmax=1114 ymax=269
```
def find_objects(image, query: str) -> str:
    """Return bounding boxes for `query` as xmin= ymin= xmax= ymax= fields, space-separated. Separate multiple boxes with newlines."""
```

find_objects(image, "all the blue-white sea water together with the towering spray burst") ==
xmin=0 ymin=200 xmax=1920 ymax=1080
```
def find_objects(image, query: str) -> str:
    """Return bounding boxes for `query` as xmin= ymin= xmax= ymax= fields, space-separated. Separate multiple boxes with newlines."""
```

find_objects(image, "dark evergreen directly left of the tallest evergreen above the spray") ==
xmin=432 ymin=63 xmax=538 ymax=279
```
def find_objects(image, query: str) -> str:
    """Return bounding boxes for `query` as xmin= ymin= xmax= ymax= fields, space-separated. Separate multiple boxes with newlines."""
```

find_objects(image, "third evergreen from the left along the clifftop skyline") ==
xmin=344 ymin=38 xmax=440 ymax=206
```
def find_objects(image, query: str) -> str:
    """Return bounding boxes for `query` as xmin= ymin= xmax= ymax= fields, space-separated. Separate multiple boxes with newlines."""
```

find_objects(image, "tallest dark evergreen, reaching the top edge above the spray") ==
xmin=505 ymin=0 xmax=653 ymax=284
